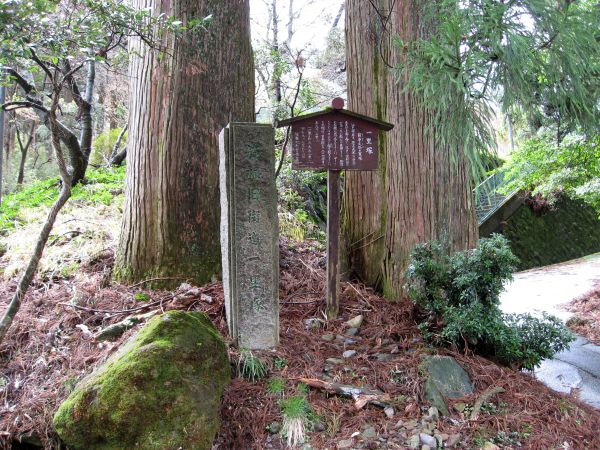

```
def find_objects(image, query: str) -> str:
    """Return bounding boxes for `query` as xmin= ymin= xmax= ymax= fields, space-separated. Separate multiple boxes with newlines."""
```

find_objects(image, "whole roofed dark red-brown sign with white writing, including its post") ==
xmin=278 ymin=97 xmax=394 ymax=319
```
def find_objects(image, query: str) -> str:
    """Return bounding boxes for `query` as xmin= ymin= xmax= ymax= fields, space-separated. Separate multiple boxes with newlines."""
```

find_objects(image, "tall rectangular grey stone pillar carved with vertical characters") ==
xmin=219 ymin=122 xmax=279 ymax=349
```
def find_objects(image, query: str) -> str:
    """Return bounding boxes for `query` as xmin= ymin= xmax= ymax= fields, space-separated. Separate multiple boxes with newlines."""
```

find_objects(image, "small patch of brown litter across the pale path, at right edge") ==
xmin=564 ymin=286 xmax=600 ymax=345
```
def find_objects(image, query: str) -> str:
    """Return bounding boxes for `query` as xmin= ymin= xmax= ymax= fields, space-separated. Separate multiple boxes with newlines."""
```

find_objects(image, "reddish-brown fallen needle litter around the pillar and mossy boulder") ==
xmin=0 ymin=244 xmax=600 ymax=450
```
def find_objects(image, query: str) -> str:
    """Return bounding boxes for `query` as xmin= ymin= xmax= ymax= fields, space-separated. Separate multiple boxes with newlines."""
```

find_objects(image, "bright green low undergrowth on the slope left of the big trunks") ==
xmin=0 ymin=167 xmax=125 ymax=232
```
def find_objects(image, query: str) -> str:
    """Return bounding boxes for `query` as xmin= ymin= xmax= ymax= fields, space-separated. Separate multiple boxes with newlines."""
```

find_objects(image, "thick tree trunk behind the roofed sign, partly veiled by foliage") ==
xmin=342 ymin=0 xmax=477 ymax=298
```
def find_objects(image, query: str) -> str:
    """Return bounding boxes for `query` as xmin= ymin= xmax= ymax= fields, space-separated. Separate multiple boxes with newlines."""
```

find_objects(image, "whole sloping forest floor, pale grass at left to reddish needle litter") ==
xmin=0 ymin=171 xmax=600 ymax=450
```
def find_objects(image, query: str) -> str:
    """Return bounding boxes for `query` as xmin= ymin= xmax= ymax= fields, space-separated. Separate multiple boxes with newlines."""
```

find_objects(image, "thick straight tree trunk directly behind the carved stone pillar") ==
xmin=115 ymin=0 xmax=254 ymax=283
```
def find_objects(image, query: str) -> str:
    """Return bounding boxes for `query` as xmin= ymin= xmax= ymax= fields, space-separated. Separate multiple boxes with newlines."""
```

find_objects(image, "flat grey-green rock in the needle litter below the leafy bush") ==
xmin=421 ymin=356 xmax=473 ymax=416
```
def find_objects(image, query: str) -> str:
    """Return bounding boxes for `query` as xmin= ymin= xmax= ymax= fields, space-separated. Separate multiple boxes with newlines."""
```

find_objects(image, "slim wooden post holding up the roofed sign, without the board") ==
xmin=327 ymin=170 xmax=340 ymax=319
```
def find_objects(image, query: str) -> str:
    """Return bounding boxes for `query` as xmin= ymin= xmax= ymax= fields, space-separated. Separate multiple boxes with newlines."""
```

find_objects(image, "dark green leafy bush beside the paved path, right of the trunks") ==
xmin=407 ymin=235 xmax=573 ymax=369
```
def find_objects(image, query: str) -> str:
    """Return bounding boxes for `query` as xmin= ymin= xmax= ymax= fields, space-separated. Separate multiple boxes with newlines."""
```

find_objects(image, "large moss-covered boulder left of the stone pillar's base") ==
xmin=54 ymin=311 xmax=231 ymax=450
